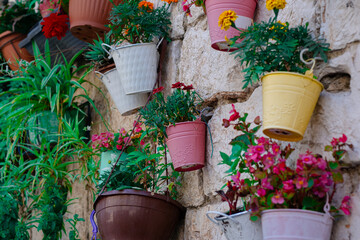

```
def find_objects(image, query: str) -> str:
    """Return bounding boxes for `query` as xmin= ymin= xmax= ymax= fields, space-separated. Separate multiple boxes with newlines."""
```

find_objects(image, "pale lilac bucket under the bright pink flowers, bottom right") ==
xmin=261 ymin=209 xmax=333 ymax=240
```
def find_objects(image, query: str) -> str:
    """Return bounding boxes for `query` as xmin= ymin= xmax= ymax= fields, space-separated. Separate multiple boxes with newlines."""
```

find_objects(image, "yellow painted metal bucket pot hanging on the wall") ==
xmin=261 ymin=72 xmax=324 ymax=142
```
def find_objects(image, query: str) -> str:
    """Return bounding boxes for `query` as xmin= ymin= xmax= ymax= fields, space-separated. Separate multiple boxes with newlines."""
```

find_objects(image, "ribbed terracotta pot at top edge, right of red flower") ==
xmin=69 ymin=0 xmax=121 ymax=42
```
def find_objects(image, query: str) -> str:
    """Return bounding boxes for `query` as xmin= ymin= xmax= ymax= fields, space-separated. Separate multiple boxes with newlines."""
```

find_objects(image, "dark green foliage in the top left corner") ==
xmin=0 ymin=0 xmax=41 ymax=34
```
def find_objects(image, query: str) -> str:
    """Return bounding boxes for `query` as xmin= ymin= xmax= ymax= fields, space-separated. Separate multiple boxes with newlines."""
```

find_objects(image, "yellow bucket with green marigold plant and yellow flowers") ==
xmin=218 ymin=0 xmax=329 ymax=141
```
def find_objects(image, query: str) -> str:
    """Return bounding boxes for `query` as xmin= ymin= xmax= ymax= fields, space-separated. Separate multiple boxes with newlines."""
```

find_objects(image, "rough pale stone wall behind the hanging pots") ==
xmin=64 ymin=0 xmax=360 ymax=240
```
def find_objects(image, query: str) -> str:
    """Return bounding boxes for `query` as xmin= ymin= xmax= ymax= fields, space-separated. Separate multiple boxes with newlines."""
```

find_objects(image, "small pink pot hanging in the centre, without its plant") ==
xmin=166 ymin=121 xmax=206 ymax=172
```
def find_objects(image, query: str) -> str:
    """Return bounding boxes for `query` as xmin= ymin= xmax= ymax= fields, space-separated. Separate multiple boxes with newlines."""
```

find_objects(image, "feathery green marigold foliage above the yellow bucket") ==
xmin=230 ymin=18 xmax=330 ymax=88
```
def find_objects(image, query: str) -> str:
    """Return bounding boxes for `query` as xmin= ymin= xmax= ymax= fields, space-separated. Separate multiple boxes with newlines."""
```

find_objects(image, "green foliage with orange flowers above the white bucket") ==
xmin=109 ymin=0 xmax=171 ymax=43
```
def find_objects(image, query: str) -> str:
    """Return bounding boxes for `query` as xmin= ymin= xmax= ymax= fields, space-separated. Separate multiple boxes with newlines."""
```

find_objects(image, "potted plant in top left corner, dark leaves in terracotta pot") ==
xmin=0 ymin=1 xmax=41 ymax=70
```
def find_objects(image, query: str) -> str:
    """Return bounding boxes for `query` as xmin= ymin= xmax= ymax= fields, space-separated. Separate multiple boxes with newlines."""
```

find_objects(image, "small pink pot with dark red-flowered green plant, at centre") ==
xmin=139 ymin=82 xmax=206 ymax=172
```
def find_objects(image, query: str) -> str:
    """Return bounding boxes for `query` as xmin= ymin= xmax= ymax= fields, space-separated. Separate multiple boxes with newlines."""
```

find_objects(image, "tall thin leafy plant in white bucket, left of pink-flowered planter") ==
xmin=206 ymin=109 xmax=263 ymax=240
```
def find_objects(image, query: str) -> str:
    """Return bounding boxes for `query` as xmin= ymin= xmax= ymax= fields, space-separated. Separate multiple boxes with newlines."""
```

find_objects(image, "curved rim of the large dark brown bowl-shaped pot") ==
xmin=93 ymin=189 xmax=186 ymax=213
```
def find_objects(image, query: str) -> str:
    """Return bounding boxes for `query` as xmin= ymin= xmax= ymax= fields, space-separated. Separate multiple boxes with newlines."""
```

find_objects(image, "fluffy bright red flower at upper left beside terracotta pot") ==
xmin=41 ymin=13 xmax=69 ymax=40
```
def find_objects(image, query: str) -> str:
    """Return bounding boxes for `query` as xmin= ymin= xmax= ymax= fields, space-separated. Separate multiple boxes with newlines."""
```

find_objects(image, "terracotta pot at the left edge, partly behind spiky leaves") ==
xmin=0 ymin=31 xmax=34 ymax=71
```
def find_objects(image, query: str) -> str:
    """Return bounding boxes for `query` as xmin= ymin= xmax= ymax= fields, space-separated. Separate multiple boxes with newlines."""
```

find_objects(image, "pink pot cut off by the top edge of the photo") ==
xmin=205 ymin=0 xmax=257 ymax=51
